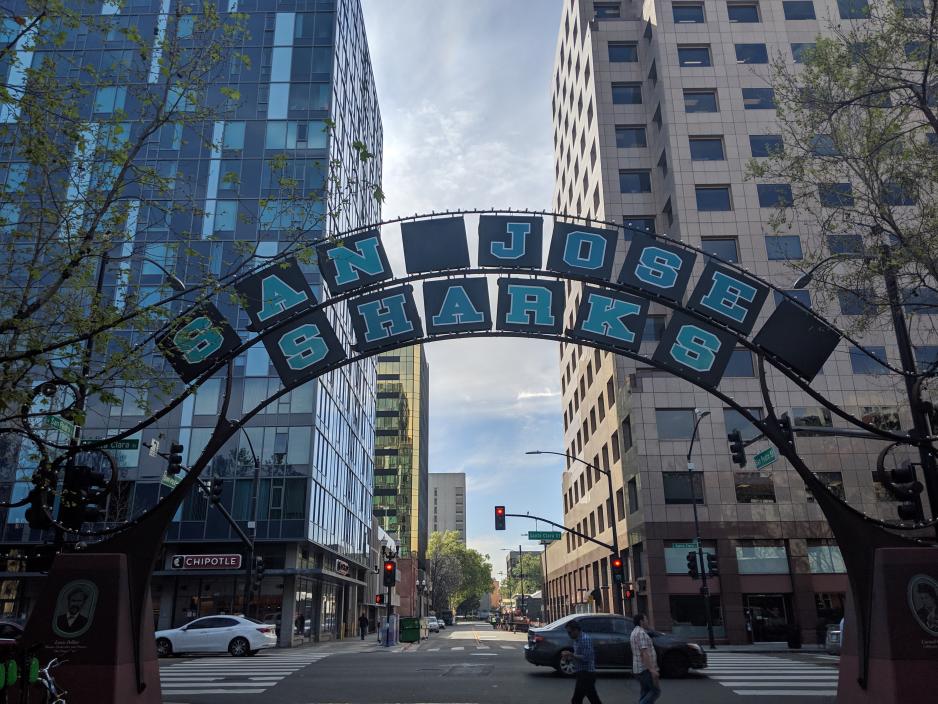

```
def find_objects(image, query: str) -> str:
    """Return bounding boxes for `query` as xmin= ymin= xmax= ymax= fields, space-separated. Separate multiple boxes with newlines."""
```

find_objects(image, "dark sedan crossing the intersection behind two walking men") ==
xmin=524 ymin=614 xmax=707 ymax=677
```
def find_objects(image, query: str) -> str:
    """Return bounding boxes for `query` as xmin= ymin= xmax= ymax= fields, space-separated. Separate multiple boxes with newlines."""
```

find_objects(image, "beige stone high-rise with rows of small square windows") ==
xmin=548 ymin=0 xmax=911 ymax=643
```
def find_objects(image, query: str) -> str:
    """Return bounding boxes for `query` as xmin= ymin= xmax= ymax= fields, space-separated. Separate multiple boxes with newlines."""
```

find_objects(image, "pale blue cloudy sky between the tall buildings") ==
xmin=362 ymin=0 xmax=563 ymax=576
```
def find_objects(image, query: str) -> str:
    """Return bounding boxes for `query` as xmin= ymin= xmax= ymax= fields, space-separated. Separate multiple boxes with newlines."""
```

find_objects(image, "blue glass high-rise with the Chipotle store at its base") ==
xmin=0 ymin=0 xmax=382 ymax=646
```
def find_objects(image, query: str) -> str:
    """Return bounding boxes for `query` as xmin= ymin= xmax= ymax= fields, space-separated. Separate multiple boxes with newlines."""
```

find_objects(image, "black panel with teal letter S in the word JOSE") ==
xmin=619 ymin=234 xmax=697 ymax=303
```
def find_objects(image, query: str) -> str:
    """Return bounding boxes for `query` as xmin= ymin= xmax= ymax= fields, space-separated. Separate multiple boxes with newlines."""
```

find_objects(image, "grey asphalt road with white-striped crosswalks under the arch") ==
xmin=160 ymin=624 xmax=837 ymax=704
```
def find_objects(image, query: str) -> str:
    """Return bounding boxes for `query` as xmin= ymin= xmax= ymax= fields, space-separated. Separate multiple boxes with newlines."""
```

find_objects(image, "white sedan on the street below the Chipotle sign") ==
xmin=156 ymin=615 xmax=277 ymax=658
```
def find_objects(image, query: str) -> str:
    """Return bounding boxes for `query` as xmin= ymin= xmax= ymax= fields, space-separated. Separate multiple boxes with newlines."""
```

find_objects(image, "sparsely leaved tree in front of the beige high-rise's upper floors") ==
xmin=750 ymin=0 xmax=938 ymax=328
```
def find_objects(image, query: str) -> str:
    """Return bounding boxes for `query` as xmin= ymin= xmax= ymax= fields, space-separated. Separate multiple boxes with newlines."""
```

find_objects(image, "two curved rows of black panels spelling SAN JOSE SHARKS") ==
xmin=158 ymin=214 xmax=841 ymax=389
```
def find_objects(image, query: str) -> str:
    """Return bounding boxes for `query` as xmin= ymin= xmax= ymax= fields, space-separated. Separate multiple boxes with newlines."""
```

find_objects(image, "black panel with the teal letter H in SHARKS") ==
xmin=349 ymin=285 xmax=423 ymax=352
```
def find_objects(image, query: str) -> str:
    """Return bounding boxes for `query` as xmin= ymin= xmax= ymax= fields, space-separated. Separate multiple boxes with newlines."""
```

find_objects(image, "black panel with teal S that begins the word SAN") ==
xmin=156 ymin=303 xmax=241 ymax=384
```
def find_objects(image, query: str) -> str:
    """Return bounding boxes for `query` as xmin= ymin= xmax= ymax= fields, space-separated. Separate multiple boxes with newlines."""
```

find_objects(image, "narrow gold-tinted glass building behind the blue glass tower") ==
xmin=374 ymin=346 xmax=430 ymax=564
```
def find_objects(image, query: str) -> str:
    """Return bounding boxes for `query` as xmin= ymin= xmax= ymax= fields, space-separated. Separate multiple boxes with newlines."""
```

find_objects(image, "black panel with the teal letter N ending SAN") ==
xmin=316 ymin=230 xmax=393 ymax=295
